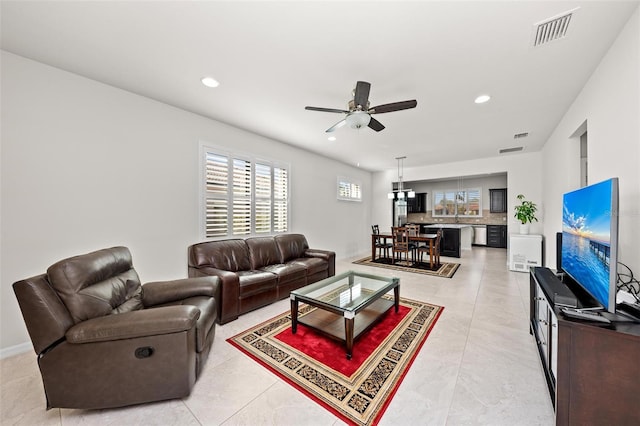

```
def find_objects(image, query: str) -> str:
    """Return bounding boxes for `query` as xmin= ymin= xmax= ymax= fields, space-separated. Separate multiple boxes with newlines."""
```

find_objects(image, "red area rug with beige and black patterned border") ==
xmin=227 ymin=296 xmax=444 ymax=425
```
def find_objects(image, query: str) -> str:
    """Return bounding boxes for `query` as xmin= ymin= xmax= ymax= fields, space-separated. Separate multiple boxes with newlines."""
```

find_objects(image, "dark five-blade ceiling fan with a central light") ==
xmin=304 ymin=81 xmax=418 ymax=133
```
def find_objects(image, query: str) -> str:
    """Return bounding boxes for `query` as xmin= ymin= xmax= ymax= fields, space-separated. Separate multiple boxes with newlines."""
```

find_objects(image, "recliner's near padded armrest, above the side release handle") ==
xmin=65 ymin=305 xmax=200 ymax=343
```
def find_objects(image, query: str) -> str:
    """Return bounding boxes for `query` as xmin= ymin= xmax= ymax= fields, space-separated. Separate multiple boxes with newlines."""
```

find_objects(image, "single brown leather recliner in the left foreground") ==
xmin=13 ymin=247 xmax=219 ymax=409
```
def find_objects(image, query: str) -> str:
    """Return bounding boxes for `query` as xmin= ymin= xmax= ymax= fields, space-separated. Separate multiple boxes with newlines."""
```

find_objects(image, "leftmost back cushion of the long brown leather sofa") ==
xmin=189 ymin=239 xmax=251 ymax=272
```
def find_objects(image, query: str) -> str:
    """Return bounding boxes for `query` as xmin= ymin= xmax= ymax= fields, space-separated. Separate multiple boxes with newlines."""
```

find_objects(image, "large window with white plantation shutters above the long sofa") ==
xmin=201 ymin=145 xmax=289 ymax=238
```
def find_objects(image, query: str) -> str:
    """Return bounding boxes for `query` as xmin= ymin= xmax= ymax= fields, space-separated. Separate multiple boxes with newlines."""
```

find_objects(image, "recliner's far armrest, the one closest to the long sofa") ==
xmin=142 ymin=276 xmax=220 ymax=307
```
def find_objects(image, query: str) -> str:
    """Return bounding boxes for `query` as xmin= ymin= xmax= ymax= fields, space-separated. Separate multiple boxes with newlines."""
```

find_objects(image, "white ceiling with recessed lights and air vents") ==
xmin=1 ymin=0 xmax=639 ymax=171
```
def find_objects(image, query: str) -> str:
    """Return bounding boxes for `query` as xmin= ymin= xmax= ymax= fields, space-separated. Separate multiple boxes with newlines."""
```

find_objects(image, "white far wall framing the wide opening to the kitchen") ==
xmin=371 ymin=152 xmax=544 ymax=234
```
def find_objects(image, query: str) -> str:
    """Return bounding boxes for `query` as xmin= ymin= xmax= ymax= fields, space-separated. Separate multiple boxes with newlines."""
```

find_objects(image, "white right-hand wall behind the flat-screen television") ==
xmin=542 ymin=9 xmax=640 ymax=276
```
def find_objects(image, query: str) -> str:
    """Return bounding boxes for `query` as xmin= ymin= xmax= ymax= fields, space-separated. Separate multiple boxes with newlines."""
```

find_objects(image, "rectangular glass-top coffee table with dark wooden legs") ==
xmin=289 ymin=271 xmax=400 ymax=359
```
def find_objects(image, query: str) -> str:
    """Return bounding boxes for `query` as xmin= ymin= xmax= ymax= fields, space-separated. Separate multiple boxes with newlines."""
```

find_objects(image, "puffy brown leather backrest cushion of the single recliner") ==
xmin=47 ymin=247 xmax=142 ymax=323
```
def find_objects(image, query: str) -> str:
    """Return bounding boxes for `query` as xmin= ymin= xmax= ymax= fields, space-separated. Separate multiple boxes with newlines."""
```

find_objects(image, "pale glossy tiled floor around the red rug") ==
xmin=0 ymin=247 xmax=554 ymax=426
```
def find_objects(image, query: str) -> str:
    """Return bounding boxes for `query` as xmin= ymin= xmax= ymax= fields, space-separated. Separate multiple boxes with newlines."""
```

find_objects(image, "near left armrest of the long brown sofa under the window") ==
xmin=189 ymin=266 xmax=240 ymax=324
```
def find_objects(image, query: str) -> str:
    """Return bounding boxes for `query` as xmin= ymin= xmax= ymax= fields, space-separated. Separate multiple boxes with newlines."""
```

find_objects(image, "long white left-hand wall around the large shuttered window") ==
xmin=0 ymin=52 xmax=371 ymax=355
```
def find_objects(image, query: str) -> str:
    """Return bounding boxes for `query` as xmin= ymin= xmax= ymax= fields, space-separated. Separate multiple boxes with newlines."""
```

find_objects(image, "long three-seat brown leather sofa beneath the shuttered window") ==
xmin=189 ymin=234 xmax=336 ymax=324
